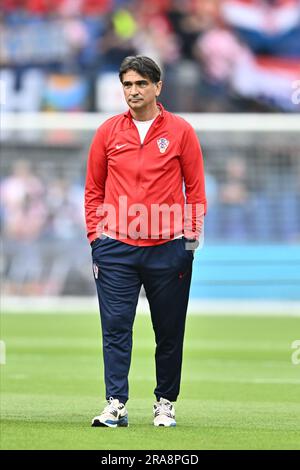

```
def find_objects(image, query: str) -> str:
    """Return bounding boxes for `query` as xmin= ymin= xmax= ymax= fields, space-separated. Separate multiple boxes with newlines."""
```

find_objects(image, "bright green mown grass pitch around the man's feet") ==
xmin=1 ymin=314 xmax=300 ymax=450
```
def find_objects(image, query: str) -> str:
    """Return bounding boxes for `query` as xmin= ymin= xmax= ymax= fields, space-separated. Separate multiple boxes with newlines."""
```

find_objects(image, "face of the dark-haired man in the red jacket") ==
xmin=122 ymin=70 xmax=162 ymax=111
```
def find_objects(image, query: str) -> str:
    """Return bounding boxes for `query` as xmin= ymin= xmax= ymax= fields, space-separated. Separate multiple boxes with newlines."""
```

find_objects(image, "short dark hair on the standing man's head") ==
xmin=119 ymin=55 xmax=161 ymax=83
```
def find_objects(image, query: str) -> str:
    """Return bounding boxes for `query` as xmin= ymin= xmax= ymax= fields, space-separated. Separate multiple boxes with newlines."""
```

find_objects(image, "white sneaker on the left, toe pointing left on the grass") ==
xmin=92 ymin=397 xmax=128 ymax=428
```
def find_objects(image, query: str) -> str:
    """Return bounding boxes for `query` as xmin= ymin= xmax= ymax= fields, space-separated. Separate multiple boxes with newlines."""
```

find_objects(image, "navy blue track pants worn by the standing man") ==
xmin=92 ymin=237 xmax=193 ymax=403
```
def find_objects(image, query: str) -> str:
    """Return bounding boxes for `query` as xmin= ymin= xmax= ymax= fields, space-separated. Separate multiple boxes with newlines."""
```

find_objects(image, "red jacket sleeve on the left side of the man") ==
xmin=84 ymin=126 xmax=107 ymax=242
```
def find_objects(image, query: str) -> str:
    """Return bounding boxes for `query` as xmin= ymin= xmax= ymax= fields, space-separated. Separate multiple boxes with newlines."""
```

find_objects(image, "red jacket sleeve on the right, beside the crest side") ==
xmin=180 ymin=124 xmax=207 ymax=239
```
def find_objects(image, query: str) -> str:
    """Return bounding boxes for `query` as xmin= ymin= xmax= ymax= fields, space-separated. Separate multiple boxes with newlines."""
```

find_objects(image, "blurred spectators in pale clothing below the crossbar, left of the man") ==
xmin=0 ymin=160 xmax=84 ymax=242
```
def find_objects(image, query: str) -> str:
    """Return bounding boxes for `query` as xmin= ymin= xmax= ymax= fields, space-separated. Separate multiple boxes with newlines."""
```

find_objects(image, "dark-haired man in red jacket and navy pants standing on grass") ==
xmin=85 ymin=56 xmax=206 ymax=427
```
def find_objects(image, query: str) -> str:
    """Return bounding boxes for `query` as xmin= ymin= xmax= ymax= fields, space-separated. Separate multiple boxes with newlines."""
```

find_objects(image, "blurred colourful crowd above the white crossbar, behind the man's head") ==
xmin=0 ymin=0 xmax=300 ymax=112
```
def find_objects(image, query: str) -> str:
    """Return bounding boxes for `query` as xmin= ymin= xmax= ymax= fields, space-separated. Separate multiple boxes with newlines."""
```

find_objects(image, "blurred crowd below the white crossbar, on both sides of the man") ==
xmin=0 ymin=150 xmax=300 ymax=243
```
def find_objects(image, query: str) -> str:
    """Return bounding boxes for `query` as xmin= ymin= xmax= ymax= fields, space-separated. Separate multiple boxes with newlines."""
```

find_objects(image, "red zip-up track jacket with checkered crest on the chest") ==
xmin=85 ymin=104 xmax=206 ymax=246
